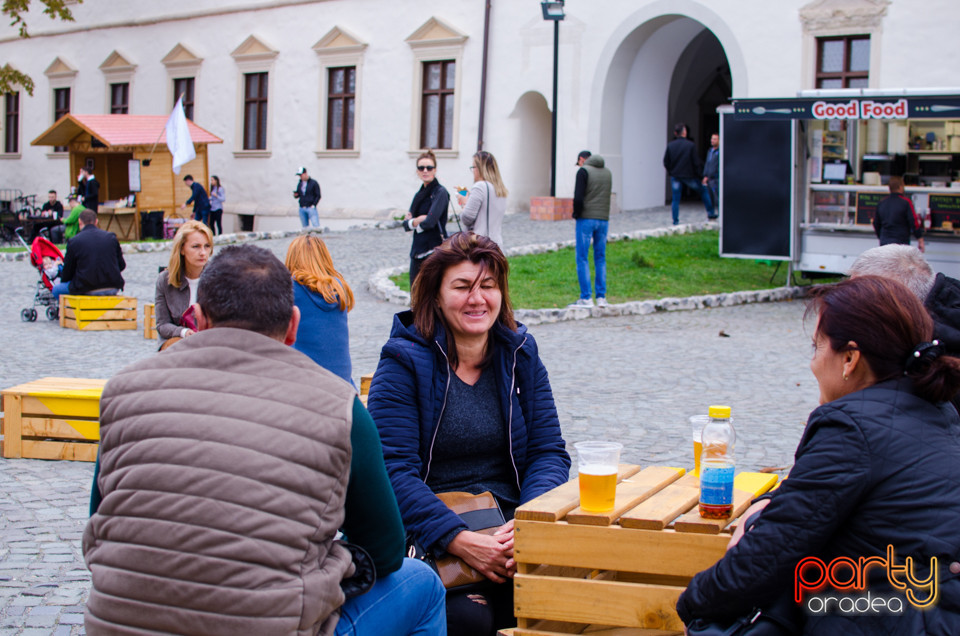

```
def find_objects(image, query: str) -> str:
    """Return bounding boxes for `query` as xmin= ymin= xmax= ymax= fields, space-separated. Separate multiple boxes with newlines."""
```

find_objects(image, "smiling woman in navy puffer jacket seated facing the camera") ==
xmin=368 ymin=232 xmax=570 ymax=636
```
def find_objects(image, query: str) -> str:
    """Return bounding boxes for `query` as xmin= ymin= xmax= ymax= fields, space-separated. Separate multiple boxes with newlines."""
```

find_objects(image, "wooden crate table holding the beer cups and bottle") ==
xmin=513 ymin=464 xmax=777 ymax=636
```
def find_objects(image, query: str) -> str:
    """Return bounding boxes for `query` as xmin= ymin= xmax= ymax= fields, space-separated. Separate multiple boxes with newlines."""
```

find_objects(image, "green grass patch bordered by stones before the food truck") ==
xmin=391 ymin=230 xmax=826 ymax=309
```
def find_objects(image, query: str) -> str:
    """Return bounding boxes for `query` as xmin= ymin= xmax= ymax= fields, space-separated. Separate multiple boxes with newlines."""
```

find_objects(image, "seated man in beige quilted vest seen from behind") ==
xmin=83 ymin=245 xmax=445 ymax=636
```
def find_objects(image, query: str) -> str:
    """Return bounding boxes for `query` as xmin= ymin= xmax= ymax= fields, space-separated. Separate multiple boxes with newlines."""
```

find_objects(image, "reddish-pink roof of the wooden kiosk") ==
xmin=30 ymin=114 xmax=223 ymax=148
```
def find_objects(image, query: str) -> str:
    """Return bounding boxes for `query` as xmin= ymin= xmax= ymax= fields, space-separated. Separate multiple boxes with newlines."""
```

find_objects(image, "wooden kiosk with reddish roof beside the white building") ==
xmin=31 ymin=114 xmax=223 ymax=241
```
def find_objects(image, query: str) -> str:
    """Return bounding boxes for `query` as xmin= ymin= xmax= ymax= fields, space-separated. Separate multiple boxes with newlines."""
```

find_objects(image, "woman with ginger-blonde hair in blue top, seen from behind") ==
xmin=284 ymin=234 xmax=356 ymax=386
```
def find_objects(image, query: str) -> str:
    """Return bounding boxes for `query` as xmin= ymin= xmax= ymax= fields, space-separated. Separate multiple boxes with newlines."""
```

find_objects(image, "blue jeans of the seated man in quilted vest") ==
xmin=334 ymin=559 xmax=447 ymax=636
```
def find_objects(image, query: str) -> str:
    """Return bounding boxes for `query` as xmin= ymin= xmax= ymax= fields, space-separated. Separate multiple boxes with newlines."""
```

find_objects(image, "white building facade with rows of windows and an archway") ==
xmin=0 ymin=0 xmax=960 ymax=231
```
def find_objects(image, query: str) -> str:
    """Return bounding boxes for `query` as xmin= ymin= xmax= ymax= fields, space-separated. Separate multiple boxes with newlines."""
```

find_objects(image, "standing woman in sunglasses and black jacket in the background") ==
xmin=403 ymin=150 xmax=450 ymax=289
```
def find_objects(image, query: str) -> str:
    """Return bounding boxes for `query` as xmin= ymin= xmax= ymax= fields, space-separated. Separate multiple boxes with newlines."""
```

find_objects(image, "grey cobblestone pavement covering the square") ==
xmin=0 ymin=206 xmax=818 ymax=636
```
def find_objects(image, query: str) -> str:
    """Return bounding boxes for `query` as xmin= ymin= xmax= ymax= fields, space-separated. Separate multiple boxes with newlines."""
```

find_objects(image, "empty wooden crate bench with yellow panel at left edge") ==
xmin=0 ymin=378 xmax=107 ymax=462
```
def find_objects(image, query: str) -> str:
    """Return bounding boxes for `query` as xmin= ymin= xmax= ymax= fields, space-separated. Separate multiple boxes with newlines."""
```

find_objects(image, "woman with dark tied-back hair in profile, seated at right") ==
xmin=677 ymin=276 xmax=960 ymax=635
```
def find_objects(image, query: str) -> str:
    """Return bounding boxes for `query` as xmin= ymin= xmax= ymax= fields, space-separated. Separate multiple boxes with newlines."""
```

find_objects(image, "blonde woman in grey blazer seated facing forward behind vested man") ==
xmin=154 ymin=220 xmax=213 ymax=351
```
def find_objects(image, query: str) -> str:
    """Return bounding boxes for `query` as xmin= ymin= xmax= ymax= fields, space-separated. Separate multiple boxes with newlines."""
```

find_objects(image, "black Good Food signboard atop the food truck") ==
xmin=733 ymin=95 xmax=960 ymax=121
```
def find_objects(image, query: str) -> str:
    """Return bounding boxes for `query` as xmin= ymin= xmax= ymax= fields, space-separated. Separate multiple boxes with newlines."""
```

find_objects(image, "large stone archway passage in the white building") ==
xmin=588 ymin=0 xmax=747 ymax=209
